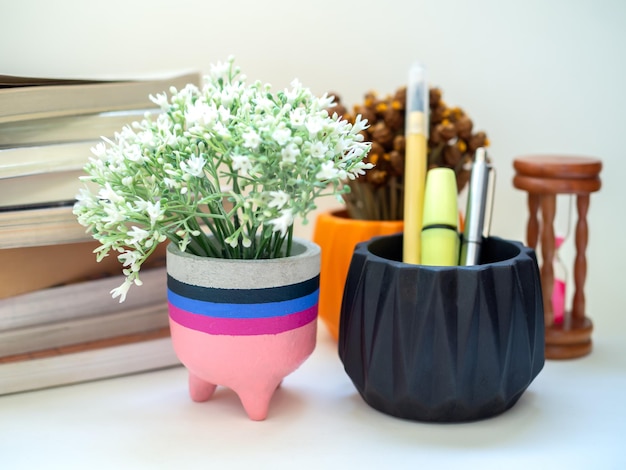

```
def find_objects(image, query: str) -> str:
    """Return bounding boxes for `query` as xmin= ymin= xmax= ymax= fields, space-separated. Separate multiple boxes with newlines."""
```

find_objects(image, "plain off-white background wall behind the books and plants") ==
xmin=0 ymin=0 xmax=626 ymax=330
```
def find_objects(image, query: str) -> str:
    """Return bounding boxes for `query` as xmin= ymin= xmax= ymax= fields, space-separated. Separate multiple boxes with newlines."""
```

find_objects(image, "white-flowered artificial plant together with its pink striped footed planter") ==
xmin=74 ymin=58 xmax=372 ymax=420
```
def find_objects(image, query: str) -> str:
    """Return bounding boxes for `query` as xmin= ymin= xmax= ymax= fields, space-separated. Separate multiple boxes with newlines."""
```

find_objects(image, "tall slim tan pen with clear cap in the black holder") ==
xmin=402 ymin=63 xmax=430 ymax=264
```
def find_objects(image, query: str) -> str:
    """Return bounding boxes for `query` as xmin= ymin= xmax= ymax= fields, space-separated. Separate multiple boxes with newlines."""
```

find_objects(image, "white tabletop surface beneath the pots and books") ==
xmin=0 ymin=327 xmax=626 ymax=470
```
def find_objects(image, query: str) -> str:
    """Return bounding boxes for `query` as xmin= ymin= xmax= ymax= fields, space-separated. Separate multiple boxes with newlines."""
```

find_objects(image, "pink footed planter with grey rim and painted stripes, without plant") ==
xmin=167 ymin=239 xmax=320 ymax=420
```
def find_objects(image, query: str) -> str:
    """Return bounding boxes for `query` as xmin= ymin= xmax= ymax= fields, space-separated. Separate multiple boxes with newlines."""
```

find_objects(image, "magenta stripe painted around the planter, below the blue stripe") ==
xmin=169 ymin=303 xmax=317 ymax=336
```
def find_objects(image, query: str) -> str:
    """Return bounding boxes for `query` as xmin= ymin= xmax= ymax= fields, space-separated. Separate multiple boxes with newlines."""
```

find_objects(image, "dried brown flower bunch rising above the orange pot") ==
xmin=333 ymin=86 xmax=489 ymax=220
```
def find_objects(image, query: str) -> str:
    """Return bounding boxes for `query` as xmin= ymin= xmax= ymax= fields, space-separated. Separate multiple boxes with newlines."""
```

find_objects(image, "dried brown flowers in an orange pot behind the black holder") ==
xmin=313 ymin=87 xmax=488 ymax=339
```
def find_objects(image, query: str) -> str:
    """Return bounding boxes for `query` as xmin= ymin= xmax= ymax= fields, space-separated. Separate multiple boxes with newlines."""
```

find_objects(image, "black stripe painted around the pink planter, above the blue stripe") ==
xmin=167 ymin=275 xmax=320 ymax=304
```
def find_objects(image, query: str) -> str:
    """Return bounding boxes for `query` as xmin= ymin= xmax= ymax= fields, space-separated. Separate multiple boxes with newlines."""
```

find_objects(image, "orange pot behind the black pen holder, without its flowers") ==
xmin=313 ymin=210 xmax=404 ymax=340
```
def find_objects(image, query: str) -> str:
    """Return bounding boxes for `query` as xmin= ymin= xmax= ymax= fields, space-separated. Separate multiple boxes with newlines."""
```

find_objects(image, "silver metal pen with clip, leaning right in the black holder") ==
xmin=459 ymin=147 xmax=495 ymax=266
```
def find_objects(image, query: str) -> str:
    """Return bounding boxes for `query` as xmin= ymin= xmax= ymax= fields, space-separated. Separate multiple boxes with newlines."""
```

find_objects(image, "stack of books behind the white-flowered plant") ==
xmin=0 ymin=72 xmax=200 ymax=395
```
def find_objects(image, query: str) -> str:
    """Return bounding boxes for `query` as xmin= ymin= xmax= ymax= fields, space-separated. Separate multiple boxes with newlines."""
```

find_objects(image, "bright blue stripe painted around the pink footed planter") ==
xmin=167 ymin=289 xmax=319 ymax=318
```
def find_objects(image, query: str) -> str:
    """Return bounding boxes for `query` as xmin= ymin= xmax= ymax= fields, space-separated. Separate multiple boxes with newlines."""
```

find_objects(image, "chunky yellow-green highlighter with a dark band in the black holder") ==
xmin=421 ymin=168 xmax=460 ymax=266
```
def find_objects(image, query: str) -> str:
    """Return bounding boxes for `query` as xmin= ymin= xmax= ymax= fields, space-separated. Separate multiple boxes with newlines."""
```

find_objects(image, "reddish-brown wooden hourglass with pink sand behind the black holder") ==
xmin=513 ymin=155 xmax=602 ymax=359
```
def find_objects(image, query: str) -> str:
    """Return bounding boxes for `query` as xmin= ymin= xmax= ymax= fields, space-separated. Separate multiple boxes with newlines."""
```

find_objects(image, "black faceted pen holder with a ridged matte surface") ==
xmin=339 ymin=233 xmax=544 ymax=422
